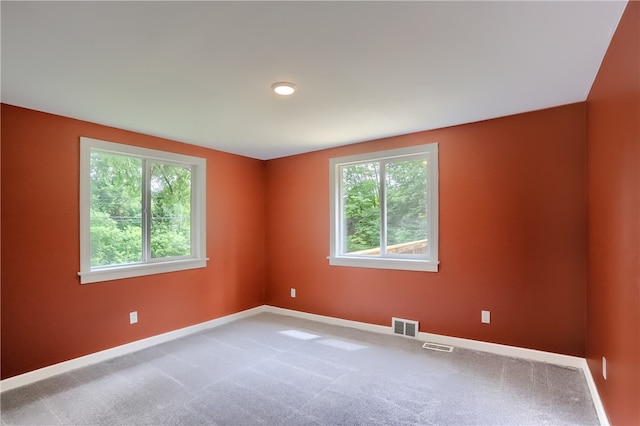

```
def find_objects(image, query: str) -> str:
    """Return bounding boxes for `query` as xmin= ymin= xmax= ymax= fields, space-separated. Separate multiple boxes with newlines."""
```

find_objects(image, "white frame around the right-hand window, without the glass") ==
xmin=328 ymin=143 xmax=440 ymax=272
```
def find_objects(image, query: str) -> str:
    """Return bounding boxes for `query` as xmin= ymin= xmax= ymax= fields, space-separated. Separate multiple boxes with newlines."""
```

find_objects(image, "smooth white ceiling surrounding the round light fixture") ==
xmin=0 ymin=1 xmax=626 ymax=159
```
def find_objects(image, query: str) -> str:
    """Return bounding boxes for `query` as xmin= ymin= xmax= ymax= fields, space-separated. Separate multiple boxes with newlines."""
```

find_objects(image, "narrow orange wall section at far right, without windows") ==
xmin=586 ymin=1 xmax=640 ymax=425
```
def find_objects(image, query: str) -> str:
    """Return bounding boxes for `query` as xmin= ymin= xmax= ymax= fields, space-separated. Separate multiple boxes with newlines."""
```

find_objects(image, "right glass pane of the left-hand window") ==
xmin=150 ymin=163 xmax=191 ymax=258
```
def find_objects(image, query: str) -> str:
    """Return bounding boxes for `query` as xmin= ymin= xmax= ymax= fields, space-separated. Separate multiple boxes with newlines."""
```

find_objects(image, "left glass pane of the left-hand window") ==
xmin=89 ymin=151 xmax=142 ymax=266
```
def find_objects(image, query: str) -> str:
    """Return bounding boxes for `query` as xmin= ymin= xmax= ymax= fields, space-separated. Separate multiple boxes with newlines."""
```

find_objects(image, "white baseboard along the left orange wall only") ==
xmin=0 ymin=305 xmax=265 ymax=392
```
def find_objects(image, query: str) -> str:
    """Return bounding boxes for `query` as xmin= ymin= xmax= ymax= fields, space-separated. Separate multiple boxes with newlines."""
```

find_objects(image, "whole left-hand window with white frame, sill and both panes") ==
xmin=79 ymin=137 xmax=207 ymax=284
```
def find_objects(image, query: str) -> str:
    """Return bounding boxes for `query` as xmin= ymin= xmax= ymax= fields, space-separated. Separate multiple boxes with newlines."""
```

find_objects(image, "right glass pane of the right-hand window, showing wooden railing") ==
xmin=385 ymin=159 xmax=428 ymax=255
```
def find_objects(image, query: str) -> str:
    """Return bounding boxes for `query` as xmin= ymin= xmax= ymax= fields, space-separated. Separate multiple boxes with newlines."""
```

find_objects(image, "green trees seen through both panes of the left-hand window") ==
xmin=90 ymin=151 xmax=191 ymax=267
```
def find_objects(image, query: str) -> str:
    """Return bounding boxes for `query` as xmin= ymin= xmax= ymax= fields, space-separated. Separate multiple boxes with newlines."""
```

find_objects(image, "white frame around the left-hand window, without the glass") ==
xmin=78 ymin=137 xmax=208 ymax=284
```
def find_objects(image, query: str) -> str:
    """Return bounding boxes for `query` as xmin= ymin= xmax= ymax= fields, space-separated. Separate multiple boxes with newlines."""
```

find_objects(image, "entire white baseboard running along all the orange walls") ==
xmin=0 ymin=305 xmax=609 ymax=426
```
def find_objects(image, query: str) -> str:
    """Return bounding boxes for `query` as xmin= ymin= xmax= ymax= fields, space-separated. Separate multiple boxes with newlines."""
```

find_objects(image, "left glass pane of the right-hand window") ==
xmin=342 ymin=162 xmax=380 ymax=256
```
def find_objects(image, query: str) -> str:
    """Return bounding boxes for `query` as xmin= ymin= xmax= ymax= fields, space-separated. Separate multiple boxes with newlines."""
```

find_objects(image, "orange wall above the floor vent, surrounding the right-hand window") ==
xmin=266 ymin=103 xmax=587 ymax=356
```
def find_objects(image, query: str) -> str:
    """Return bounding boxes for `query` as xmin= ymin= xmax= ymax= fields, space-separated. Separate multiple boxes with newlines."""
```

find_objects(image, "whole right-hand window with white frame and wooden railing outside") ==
xmin=329 ymin=143 xmax=439 ymax=272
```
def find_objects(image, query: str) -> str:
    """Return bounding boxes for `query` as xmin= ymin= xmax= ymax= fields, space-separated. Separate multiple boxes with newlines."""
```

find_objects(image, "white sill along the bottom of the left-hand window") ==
xmin=78 ymin=258 xmax=209 ymax=284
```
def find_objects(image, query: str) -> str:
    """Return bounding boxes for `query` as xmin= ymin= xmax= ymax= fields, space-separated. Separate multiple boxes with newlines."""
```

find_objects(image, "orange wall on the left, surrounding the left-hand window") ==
xmin=1 ymin=105 xmax=265 ymax=378
